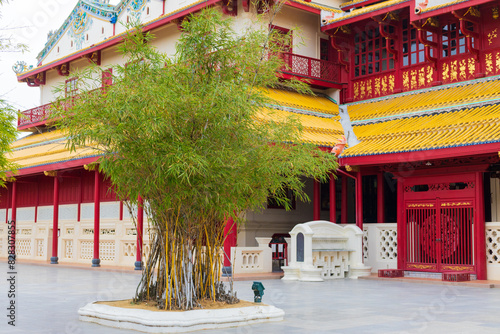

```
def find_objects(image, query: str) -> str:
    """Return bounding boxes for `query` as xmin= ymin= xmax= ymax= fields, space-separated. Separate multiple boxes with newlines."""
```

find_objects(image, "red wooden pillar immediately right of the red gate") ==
xmin=474 ymin=172 xmax=487 ymax=280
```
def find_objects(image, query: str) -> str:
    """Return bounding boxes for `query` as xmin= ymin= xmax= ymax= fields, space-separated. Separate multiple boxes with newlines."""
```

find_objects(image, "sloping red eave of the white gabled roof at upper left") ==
xmin=17 ymin=0 xmax=221 ymax=82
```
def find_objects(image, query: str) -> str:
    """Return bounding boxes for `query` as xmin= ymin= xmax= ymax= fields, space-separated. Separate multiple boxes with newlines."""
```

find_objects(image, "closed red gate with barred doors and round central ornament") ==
xmin=398 ymin=173 xmax=478 ymax=273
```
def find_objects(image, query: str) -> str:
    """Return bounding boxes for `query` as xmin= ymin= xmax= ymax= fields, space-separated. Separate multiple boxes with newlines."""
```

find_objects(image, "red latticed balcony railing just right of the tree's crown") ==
xmin=282 ymin=53 xmax=340 ymax=82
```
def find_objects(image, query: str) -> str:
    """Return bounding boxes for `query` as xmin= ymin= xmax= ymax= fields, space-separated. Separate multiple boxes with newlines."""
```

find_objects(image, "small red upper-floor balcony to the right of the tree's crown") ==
xmin=281 ymin=53 xmax=341 ymax=88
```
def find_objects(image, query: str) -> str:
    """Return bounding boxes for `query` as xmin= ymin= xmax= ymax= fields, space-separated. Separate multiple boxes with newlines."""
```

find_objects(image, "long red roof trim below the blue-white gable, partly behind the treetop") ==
xmin=17 ymin=0 xmax=221 ymax=82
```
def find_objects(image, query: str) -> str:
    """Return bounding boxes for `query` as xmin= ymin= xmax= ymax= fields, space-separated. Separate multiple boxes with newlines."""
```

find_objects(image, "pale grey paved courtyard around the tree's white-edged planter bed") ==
xmin=0 ymin=261 xmax=500 ymax=334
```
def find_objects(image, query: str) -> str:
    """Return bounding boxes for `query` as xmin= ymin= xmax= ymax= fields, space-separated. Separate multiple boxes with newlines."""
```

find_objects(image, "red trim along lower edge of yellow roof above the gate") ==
xmin=339 ymin=143 xmax=500 ymax=166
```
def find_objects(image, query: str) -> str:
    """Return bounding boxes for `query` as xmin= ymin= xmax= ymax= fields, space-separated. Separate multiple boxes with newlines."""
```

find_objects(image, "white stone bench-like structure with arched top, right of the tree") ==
xmin=282 ymin=220 xmax=371 ymax=282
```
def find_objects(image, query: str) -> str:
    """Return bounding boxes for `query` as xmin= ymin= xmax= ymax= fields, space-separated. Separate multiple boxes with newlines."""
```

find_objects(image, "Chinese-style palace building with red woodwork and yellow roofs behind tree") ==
xmin=0 ymin=0 xmax=500 ymax=279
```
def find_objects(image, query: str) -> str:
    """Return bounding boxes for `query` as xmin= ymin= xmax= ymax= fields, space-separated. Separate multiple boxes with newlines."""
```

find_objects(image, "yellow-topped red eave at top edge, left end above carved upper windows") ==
xmin=321 ymin=0 xmax=413 ymax=32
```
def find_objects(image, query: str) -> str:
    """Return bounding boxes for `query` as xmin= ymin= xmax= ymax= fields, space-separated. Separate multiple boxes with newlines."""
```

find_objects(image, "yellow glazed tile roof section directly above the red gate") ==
xmin=342 ymin=78 xmax=500 ymax=157
